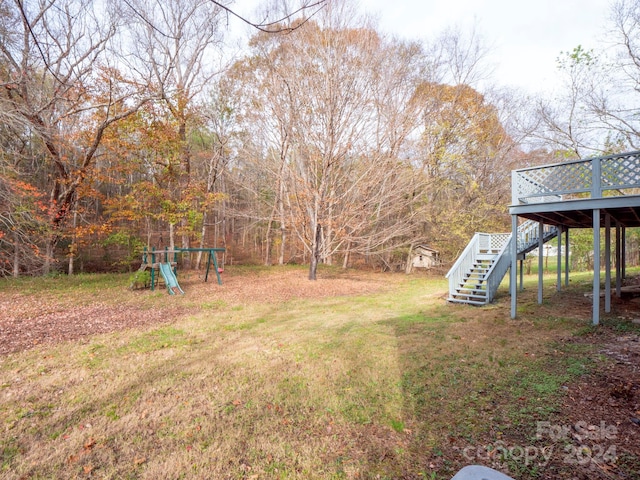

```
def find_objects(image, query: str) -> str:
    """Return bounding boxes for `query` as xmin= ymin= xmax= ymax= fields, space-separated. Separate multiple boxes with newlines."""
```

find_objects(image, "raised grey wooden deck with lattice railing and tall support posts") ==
xmin=509 ymin=152 xmax=640 ymax=325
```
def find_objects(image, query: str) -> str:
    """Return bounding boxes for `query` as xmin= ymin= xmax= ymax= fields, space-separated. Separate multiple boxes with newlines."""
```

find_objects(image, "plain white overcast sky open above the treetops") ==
xmin=236 ymin=0 xmax=611 ymax=92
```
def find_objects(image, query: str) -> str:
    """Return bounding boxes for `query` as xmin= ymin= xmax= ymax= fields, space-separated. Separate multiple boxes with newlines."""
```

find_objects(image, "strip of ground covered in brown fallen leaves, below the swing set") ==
xmin=0 ymin=268 xmax=402 ymax=355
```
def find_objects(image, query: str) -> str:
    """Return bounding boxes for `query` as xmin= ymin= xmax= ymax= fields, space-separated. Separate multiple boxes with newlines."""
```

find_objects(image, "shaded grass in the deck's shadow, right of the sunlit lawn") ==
xmin=380 ymin=277 xmax=640 ymax=480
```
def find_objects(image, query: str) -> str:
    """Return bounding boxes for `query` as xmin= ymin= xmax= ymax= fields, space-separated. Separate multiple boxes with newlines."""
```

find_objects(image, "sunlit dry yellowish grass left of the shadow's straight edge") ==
xmin=0 ymin=271 xmax=424 ymax=478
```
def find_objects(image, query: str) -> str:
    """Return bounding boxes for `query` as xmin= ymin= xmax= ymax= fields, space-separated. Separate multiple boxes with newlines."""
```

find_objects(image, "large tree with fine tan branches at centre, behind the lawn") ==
xmin=225 ymin=2 xmax=436 ymax=279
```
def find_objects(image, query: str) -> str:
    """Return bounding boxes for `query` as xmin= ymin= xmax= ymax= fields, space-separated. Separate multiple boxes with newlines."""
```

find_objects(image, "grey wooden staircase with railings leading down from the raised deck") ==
xmin=446 ymin=221 xmax=558 ymax=305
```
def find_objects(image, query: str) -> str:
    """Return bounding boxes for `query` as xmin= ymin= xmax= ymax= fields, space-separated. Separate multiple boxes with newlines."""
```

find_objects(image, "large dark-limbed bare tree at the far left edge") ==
xmin=0 ymin=0 xmax=144 ymax=273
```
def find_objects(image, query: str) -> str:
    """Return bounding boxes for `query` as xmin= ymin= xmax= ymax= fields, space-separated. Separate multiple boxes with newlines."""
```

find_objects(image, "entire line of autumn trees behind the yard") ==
xmin=0 ymin=0 xmax=640 ymax=279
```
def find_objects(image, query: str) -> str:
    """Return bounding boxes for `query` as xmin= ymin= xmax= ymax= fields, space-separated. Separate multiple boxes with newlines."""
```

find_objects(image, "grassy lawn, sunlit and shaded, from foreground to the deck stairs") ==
xmin=0 ymin=268 xmax=640 ymax=479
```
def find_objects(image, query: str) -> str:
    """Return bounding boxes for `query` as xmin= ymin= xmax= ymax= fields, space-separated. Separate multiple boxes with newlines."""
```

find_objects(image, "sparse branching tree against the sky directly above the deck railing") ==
xmin=531 ymin=0 xmax=640 ymax=157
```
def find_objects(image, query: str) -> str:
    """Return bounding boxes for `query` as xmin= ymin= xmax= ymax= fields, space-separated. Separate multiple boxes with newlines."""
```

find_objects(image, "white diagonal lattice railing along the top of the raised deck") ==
xmin=511 ymin=152 xmax=640 ymax=205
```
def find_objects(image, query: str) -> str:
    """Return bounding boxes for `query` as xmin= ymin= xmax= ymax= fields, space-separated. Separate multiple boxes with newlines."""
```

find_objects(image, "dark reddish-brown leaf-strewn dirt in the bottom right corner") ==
xmin=542 ymin=329 xmax=640 ymax=480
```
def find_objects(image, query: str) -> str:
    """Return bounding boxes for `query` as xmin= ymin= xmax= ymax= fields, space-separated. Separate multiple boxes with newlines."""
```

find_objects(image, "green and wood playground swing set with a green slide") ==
xmin=138 ymin=247 xmax=225 ymax=295
